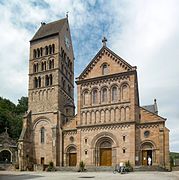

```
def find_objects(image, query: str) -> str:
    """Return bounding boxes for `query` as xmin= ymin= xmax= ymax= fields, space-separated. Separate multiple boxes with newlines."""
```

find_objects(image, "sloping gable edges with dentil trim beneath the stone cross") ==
xmin=78 ymin=46 xmax=133 ymax=79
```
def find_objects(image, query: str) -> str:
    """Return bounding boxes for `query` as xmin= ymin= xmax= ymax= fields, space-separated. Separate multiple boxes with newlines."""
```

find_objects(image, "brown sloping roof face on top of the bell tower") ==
xmin=31 ymin=18 xmax=67 ymax=41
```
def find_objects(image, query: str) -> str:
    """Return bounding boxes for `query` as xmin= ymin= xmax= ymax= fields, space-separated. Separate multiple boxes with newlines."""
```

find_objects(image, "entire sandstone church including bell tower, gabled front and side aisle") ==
xmin=19 ymin=18 xmax=169 ymax=169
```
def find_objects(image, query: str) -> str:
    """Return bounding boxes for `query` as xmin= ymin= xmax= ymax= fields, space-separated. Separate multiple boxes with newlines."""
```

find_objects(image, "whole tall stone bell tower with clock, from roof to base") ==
xmin=19 ymin=17 xmax=75 ymax=169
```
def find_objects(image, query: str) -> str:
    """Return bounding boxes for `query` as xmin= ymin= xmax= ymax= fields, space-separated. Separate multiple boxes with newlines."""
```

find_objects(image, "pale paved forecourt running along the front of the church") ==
xmin=0 ymin=171 xmax=179 ymax=180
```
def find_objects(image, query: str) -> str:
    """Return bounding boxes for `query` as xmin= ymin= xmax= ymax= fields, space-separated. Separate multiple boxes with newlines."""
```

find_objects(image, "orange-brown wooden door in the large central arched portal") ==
xmin=100 ymin=148 xmax=112 ymax=166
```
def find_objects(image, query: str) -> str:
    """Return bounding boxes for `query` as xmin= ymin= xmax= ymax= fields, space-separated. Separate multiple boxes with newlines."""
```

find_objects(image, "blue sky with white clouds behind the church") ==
xmin=0 ymin=0 xmax=179 ymax=152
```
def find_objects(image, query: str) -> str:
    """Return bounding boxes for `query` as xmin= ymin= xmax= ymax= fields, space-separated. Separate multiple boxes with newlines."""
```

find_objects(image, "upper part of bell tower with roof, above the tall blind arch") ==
xmin=29 ymin=18 xmax=74 ymax=116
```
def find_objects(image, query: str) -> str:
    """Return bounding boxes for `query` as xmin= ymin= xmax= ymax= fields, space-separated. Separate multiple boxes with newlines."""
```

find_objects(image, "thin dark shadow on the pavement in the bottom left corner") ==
xmin=0 ymin=174 xmax=43 ymax=180
